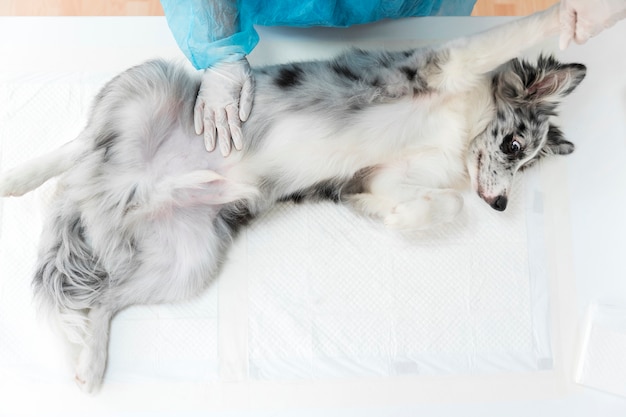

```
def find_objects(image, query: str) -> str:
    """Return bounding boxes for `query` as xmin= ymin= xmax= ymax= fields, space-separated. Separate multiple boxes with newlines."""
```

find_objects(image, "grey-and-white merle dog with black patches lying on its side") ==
xmin=0 ymin=5 xmax=586 ymax=392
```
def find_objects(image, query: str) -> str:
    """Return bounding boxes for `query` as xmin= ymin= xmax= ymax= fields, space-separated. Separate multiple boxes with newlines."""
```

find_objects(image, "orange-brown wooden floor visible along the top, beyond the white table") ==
xmin=0 ymin=0 xmax=557 ymax=16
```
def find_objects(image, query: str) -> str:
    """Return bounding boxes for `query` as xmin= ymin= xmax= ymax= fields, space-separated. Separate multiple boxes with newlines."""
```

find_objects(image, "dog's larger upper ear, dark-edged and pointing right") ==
xmin=526 ymin=55 xmax=587 ymax=101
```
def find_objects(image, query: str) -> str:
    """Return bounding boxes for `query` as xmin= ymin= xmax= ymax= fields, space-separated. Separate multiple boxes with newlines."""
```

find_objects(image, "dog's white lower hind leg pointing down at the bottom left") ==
xmin=76 ymin=306 xmax=114 ymax=393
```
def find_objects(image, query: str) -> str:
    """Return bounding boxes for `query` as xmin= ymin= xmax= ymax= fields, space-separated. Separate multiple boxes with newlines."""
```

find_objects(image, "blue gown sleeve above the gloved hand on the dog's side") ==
xmin=161 ymin=0 xmax=259 ymax=69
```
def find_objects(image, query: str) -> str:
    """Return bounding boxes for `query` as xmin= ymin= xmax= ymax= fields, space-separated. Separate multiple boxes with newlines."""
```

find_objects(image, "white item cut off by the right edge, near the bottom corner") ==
xmin=575 ymin=302 xmax=626 ymax=397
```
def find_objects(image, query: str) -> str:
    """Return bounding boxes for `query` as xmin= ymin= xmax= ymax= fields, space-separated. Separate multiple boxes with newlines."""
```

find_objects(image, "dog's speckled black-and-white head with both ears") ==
xmin=467 ymin=56 xmax=586 ymax=211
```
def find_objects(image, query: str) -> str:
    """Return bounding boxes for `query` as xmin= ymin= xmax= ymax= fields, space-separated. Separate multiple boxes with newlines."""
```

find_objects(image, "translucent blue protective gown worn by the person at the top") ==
xmin=161 ymin=0 xmax=476 ymax=69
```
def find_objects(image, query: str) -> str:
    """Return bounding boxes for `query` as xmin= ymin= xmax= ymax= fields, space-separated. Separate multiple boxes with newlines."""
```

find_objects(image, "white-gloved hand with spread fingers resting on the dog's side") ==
xmin=194 ymin=58 xmax=254 ymax=156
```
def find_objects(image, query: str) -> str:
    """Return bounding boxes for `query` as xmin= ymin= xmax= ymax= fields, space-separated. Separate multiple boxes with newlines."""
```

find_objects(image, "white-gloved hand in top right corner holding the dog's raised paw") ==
xmin=559 ymin=0 xmax=626 ymax=49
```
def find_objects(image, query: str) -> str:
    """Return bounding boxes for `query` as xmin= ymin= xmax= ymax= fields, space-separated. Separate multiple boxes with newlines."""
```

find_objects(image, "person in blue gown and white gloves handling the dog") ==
xmin=161 ymin=0 xmax=626 ymax=156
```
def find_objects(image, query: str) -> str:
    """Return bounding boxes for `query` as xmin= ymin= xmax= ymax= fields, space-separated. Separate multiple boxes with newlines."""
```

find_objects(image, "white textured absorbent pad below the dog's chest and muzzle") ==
xmin=246 ymin=197 xmax=552 ymax=379
